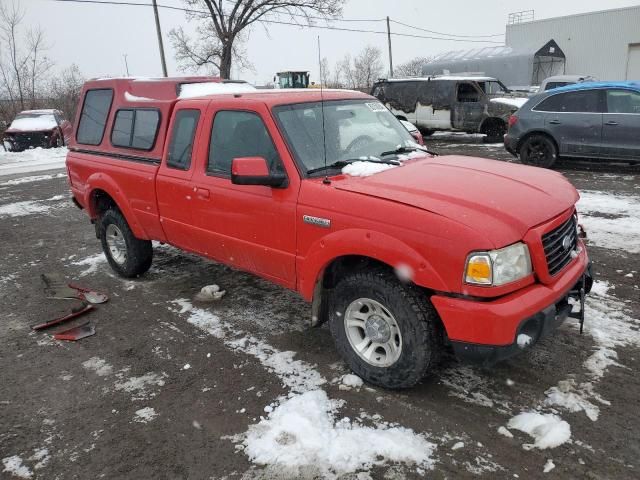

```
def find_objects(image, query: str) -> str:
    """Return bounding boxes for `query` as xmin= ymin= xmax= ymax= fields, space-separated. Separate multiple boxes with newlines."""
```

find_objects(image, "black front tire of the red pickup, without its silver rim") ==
xmin=329 ymin=269 xmax=443 ymax=389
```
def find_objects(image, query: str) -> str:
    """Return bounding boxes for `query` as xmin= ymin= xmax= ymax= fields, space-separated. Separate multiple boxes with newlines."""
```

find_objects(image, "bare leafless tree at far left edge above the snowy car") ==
xmin=0 ymin=1 xmax=53 ymax=109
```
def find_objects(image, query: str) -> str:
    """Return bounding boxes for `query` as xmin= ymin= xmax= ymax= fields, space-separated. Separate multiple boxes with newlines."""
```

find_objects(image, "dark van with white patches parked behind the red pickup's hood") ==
xmin=371 ymin=76 xmax=527 ymax=142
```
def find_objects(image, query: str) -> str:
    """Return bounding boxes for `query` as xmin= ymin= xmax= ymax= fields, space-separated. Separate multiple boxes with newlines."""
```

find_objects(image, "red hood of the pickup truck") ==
xmin=333 ymin=156 xmax=579 ymax=248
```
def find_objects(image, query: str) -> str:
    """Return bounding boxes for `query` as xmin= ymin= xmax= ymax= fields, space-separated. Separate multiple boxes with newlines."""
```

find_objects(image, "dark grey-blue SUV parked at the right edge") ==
xmin=504 ymin=82 xmax=640 ymax=168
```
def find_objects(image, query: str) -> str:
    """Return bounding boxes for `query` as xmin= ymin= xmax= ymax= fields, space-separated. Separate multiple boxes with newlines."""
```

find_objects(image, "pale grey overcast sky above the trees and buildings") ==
xmin=18 ymin=0 xmax=639 ymax=84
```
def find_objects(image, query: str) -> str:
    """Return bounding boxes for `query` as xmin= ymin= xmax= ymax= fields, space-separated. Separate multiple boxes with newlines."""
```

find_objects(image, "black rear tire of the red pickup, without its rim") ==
xmin=100 ymin=209 xmax=153 ymax=278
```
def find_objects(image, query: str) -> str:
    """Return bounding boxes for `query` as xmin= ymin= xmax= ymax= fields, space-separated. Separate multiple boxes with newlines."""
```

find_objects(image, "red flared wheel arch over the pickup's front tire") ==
xmin=297 ymin=229 xmax=448 ymax=301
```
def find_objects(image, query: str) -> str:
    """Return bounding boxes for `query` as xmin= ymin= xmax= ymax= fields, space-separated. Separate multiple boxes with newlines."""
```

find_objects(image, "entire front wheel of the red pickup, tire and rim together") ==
xmin=329 ymin=270 xmax=442 ymax=388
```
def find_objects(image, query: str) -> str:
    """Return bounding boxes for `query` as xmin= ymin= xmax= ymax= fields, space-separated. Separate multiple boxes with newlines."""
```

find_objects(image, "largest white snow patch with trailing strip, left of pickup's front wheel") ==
xmin=170 ymin=299 xmax=436 ymax=478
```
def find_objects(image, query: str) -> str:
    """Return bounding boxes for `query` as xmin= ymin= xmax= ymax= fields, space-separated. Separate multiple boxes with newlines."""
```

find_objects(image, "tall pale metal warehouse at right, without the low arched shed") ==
xmin=506 ymin=5 xmax=640 ymax=80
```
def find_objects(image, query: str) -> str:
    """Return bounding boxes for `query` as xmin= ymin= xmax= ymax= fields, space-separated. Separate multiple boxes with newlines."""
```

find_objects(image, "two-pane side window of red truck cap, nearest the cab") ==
xmin=111 ymin=108 xmax=160 ymax=150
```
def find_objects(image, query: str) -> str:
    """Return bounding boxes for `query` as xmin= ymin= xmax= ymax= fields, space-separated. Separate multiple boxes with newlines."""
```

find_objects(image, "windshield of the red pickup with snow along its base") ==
xmin=273 ymin=99 xmax=420 ymax=173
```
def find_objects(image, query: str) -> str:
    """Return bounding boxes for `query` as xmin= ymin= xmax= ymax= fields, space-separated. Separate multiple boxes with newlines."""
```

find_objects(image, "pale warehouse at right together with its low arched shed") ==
xmin=422 ymin=5 xmax=640 ymax=87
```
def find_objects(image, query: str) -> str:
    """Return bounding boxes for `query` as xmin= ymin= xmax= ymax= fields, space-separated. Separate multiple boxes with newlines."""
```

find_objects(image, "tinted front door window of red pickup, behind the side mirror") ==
xmin=207 ymin=111 xmax=282 ymax=176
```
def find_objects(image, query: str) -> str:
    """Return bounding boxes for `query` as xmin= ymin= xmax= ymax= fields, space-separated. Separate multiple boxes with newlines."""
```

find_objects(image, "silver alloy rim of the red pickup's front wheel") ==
xmin=344 ymin=298 xmax=402 ymax=367
